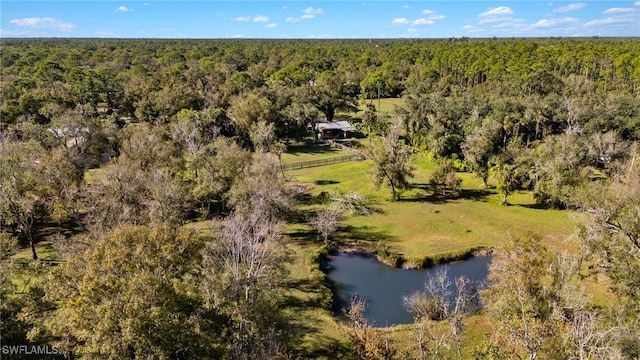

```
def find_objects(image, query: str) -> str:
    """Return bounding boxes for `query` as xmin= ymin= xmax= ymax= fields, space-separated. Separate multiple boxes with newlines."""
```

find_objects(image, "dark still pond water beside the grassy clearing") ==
xmin=328 ymin=252 xmax=491 ymax=327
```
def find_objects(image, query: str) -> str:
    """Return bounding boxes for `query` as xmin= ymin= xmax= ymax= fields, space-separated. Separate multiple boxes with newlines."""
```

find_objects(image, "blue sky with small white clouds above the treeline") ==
xmin=0 ymin=0 xmax=640 ymax=39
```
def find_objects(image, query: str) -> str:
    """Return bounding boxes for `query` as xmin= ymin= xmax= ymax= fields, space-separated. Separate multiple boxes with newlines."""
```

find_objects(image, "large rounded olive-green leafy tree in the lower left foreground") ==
xmin=47 ymin=225 xmax=225 ymax=359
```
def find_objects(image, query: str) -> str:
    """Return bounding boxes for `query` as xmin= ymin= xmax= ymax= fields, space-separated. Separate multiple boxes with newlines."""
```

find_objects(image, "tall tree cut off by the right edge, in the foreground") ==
xmin=579 ymin=150 xmax=640 ymax=358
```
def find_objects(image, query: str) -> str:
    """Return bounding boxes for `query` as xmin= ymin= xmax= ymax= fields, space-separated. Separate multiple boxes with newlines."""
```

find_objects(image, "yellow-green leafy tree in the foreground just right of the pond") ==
xmin=482 ymin=234 xmax=563 ymax=360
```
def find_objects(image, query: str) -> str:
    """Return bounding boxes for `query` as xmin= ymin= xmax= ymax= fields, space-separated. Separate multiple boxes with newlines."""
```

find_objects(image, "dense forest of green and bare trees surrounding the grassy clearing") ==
xmin=0 ymin=38 xmax=640 ymax=359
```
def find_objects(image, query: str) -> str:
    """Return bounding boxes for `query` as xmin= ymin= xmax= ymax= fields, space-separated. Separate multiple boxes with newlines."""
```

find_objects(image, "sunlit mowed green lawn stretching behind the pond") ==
xmin=286 ymin=150 xmax=575 ymax=266
